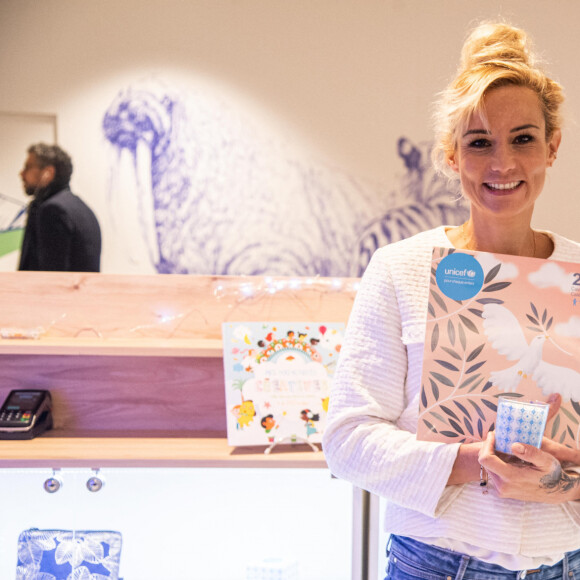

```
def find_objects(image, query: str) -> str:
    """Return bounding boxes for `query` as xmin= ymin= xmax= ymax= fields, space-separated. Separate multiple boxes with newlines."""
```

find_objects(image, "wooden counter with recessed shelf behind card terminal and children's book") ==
xmin=0 ymin=272 xmax=358 ymax=468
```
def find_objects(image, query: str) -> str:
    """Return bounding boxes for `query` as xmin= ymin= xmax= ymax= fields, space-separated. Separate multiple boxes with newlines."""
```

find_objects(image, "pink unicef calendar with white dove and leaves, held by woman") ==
xmin=417 ymin=248 xmax=580 ymax=447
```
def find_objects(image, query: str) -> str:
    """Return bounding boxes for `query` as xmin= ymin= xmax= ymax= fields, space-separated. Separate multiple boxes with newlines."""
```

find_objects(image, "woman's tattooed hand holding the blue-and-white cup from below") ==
xmin=479 ymin=431 xmax=580 ymax=503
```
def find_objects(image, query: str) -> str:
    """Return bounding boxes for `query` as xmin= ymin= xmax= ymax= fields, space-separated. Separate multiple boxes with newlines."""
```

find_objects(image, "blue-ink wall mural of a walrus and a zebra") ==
xmin=102 ymin=79 xmax=467 ymax=276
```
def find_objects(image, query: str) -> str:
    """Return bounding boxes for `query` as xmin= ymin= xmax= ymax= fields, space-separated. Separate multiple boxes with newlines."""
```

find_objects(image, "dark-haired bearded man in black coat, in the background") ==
xmin=18 ymin=143 xmax=101 ymax=272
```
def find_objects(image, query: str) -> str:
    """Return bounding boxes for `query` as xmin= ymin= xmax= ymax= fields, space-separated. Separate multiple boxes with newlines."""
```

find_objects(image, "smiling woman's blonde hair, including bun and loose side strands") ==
xmin=431 ymin=22 xmax=564 ymax=177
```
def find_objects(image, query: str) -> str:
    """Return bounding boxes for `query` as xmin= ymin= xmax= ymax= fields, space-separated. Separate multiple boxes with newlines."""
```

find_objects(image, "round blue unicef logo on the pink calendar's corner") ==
xmin=435 ymin=252 xmax=483 ymax=300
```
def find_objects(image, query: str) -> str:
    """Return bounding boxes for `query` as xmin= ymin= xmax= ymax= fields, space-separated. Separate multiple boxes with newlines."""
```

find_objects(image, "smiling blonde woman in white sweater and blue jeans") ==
xmin=323 ymin=23 xmax=580 ymax=580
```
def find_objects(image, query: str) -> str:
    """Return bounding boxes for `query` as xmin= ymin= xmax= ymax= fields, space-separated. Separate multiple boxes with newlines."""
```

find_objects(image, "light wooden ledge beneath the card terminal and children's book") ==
xmin=0 ymin=436 xmax=326 ymax=469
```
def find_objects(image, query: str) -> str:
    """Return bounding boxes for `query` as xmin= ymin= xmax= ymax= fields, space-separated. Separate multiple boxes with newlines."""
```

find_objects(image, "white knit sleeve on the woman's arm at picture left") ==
xmin=323 ymin=227 xmax=460 ymax=516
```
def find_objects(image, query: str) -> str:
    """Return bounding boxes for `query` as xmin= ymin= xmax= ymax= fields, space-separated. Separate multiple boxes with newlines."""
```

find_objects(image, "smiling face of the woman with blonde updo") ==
xmin=448 ymin=85 xmax=561 ymax=220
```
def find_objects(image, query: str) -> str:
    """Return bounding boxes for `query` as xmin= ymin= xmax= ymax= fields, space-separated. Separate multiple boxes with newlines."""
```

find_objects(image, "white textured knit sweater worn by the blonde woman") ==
xmin=323 ymin=226 xmax=580 ymax=569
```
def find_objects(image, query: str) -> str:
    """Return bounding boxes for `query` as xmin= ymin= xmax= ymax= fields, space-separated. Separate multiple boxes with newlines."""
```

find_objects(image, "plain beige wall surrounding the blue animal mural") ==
xmin=0 ymin=0 xmax=580 ymax=270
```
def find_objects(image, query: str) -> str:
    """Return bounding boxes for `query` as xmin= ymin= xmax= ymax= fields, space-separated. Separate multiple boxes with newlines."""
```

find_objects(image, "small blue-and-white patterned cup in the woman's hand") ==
xmin=495 ymin=395 xmax=550 ymax=454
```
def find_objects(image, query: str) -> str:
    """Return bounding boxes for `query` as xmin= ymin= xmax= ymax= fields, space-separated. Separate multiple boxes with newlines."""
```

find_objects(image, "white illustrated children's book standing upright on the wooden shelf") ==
xmin=222 ymin=322 xmax=345 ymax=446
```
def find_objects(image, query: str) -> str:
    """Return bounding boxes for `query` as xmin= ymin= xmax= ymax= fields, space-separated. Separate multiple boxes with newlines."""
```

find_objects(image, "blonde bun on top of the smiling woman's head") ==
xmin=461 ymin=22 xmax=535 ymax=70
